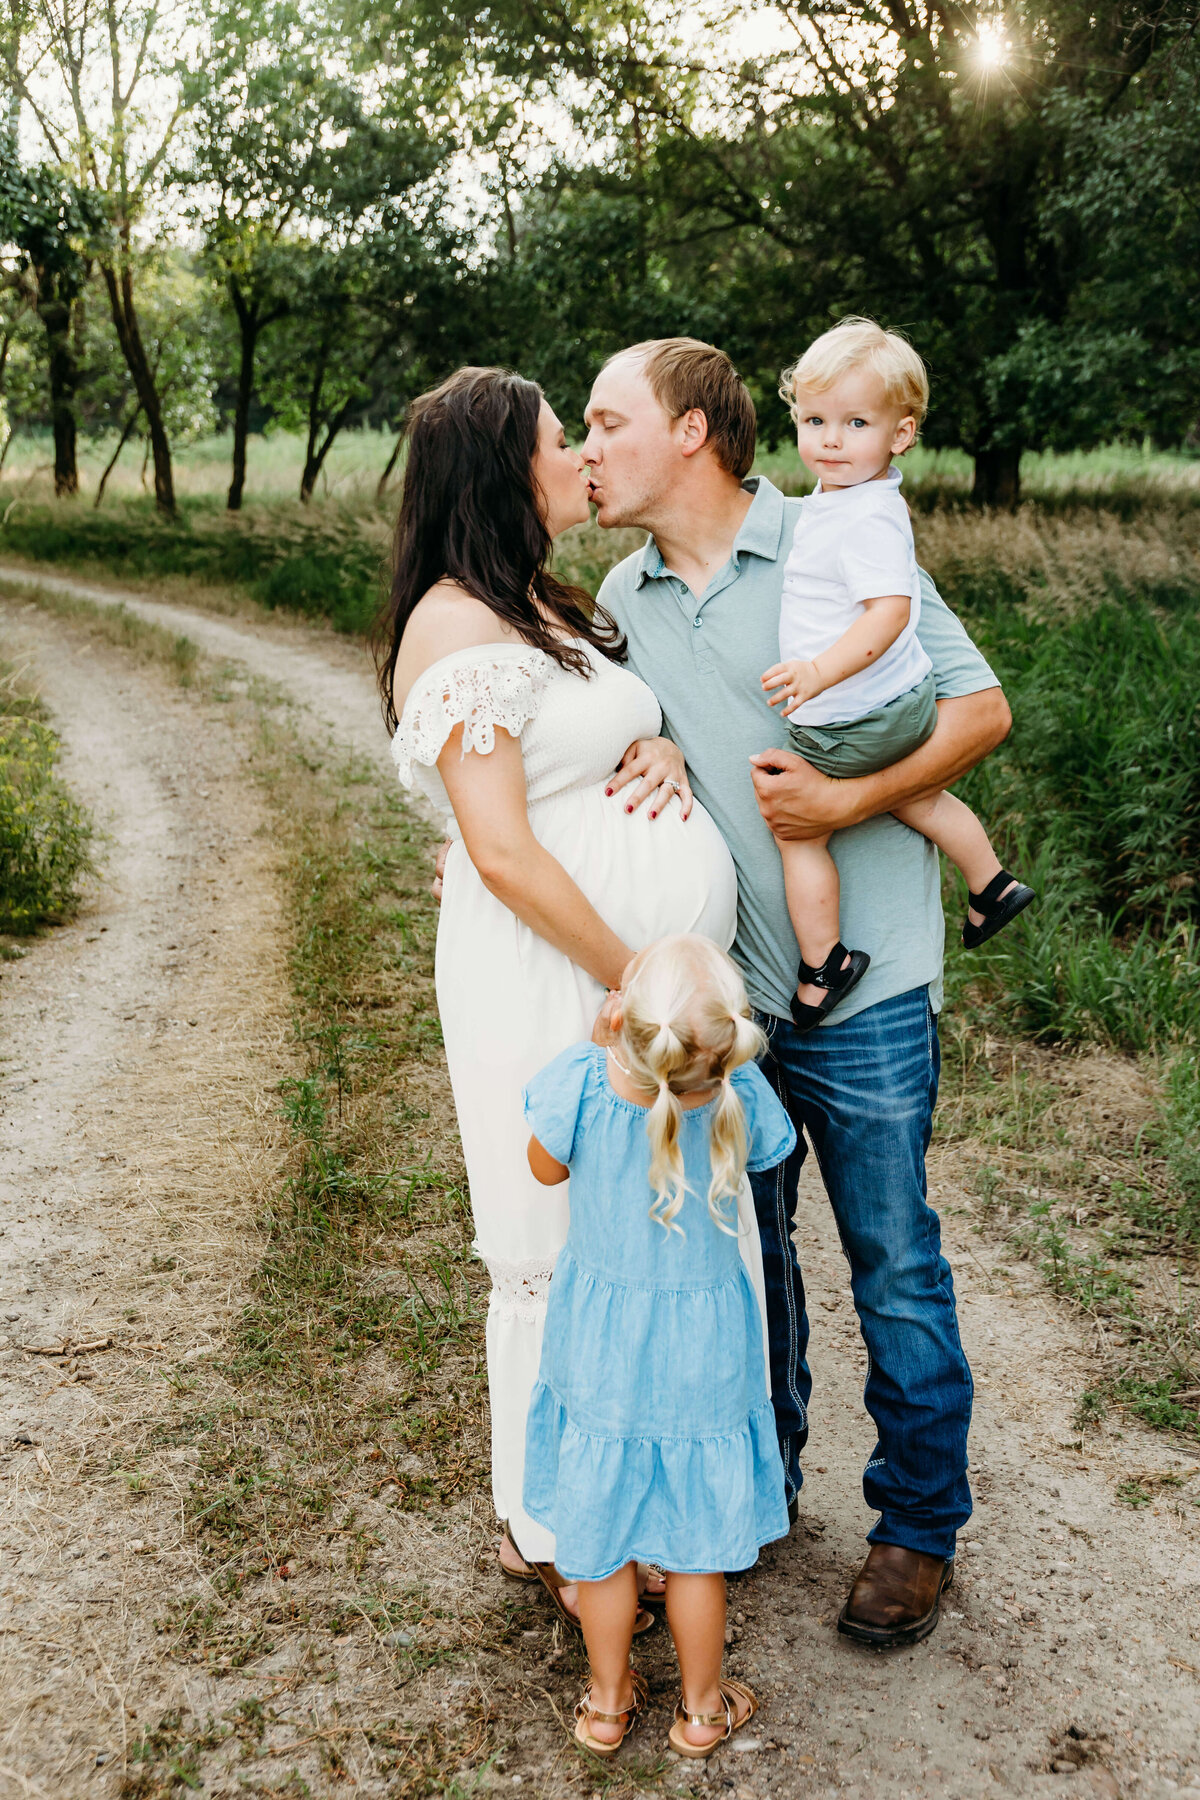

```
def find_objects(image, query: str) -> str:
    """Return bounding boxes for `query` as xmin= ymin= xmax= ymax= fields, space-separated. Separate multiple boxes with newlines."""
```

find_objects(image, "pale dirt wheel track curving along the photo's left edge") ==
xmin=0 ymin=607 xmax=288 ymax=1800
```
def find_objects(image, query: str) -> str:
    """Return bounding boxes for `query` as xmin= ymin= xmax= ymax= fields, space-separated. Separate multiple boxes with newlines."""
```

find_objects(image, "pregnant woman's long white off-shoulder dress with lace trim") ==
xmin=392 ymin=641 xmax=761 ymax=1562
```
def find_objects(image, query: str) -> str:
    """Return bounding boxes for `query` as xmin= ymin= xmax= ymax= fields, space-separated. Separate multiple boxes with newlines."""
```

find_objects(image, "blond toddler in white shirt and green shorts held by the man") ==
xmin=763 ymin=319 xmax=1036 ymax=1031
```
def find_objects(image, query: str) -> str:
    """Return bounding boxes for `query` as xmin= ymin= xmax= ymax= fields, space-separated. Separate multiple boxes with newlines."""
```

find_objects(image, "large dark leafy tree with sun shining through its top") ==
xmin=399 ymin=0 xmax=1195 ymax=504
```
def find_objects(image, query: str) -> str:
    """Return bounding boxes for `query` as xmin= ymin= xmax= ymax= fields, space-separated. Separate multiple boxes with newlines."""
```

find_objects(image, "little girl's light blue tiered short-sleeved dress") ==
xmin=525 ymin=1044 xmax=795 ymax=1580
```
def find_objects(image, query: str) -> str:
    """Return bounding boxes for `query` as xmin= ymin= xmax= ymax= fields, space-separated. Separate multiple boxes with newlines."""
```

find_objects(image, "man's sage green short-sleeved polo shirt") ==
xmin=599 ymin=477 xmax=999 ymax=1022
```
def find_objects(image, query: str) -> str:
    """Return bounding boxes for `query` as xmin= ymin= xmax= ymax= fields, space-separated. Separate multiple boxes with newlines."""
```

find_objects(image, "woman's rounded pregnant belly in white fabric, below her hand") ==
xmin=531 ymin=783 xmax=738 ymax=950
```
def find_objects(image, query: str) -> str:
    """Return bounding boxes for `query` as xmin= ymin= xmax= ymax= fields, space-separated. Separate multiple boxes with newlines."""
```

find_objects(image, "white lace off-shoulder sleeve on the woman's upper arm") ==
xmin=392 ymin=646 xmax=554 ymax=787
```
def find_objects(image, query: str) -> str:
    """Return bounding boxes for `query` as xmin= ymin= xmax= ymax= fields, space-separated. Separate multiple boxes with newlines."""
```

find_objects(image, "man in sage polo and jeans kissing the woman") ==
xmin=583 ymin=338 xmax=1011 ymax=1645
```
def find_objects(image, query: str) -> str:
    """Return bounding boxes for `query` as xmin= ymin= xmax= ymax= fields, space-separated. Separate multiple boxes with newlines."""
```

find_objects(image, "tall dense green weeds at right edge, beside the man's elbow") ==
xmin=945 ymin=590 xmax=1200 ymax=1051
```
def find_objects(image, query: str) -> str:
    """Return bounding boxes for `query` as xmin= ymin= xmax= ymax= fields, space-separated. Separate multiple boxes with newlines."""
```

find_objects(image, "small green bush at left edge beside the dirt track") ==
xmin=0 ymin=666 xmax=92 ymax=936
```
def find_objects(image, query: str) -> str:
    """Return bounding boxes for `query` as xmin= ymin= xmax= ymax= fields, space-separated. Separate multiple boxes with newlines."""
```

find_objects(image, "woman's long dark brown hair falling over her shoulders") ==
xmin=374 ymin=369 xmax=626 ymax=731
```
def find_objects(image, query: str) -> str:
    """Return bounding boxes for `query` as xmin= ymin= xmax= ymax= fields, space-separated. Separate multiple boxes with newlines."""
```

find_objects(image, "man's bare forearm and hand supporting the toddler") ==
xmin=750 ymin=688 xmax=1013 ymax=839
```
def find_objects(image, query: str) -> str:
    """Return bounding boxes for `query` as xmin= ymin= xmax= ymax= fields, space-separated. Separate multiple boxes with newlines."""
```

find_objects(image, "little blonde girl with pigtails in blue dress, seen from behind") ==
xmin=525 ymin=936 xmax=795 ymax=1757
